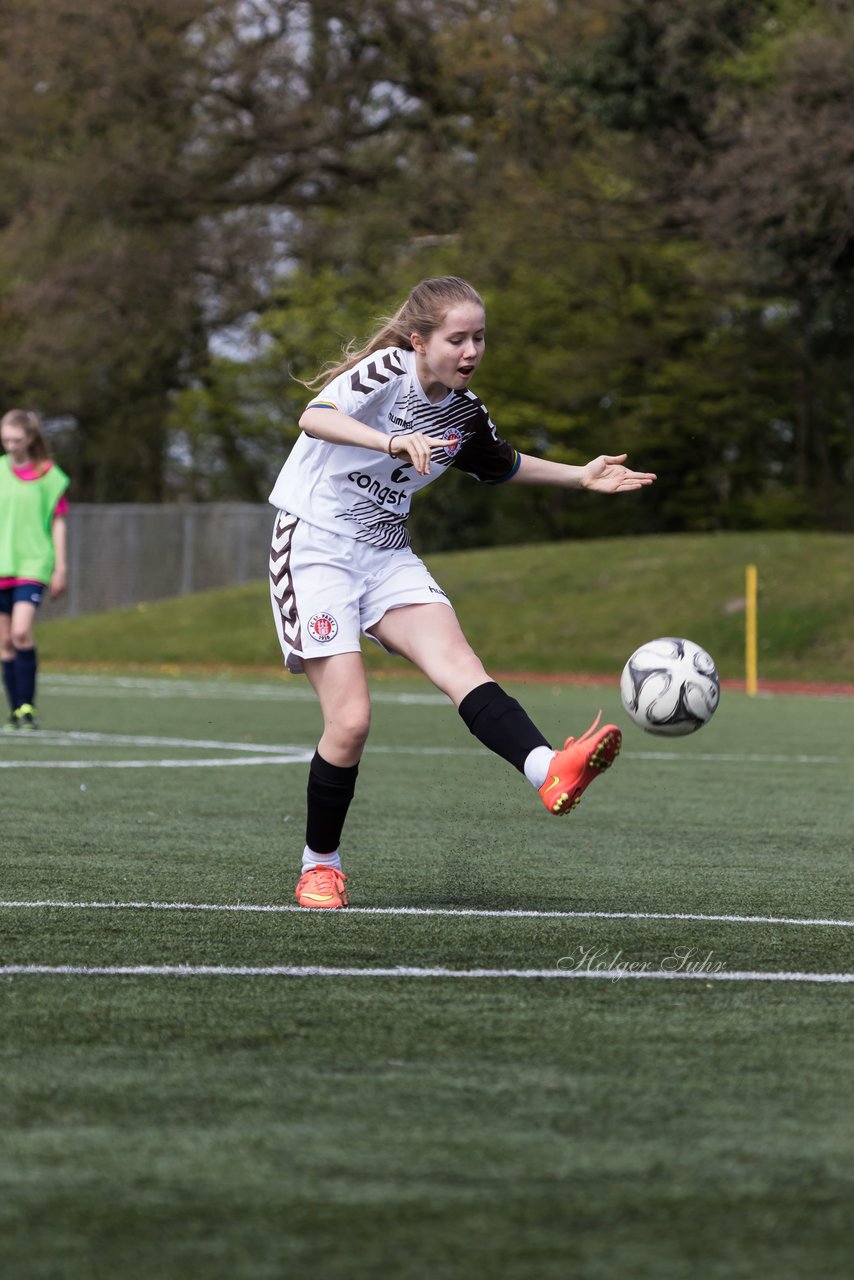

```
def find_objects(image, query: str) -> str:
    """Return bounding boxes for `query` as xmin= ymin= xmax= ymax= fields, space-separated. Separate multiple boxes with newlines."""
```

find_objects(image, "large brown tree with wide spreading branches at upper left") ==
xmin=0 ymin=0 xmax=481 ymax=500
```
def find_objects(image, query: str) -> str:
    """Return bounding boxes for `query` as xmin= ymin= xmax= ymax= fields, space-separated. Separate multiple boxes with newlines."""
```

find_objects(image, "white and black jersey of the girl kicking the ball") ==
xmin=269 ymin=347 xmax=519 ymax=548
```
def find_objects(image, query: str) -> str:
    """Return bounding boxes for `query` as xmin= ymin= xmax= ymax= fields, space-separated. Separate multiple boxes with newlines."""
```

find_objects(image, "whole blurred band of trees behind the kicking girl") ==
xmin=0 ymin=0 xmax=854 ymax=527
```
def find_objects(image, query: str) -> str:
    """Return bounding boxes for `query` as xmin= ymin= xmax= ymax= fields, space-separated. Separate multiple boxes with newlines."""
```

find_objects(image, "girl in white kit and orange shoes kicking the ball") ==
xmin=270 ymin=276 xmax=656 ymax=909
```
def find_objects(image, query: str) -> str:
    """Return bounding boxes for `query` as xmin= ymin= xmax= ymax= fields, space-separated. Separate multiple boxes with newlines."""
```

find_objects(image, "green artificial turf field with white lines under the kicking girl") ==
xmin=0 ymin=672 xmax=854 ymax=1280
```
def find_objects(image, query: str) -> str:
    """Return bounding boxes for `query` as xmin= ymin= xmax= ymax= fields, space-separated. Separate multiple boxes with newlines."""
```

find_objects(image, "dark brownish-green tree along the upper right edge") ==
xmin=570 ymin=0 xmax=854 ymax=527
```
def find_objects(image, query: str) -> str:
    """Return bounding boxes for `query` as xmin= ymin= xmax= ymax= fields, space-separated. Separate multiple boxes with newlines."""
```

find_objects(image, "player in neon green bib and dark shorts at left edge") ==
xmin=0 ymin=408 xmax=68 ymax=730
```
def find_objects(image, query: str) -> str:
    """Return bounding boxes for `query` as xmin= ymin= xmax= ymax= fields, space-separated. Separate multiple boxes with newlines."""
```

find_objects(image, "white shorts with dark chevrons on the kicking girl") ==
xmin=270 ymin=511 xmax=452 ymax=675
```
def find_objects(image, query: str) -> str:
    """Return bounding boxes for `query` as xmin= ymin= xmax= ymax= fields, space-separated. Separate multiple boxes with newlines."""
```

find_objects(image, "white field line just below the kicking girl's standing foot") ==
xmin=0 ymin=899 xmax=854 ymax=929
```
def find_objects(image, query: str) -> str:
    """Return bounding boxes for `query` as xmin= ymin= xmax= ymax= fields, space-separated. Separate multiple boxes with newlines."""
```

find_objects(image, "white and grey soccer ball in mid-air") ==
xmin=620 ymin=636 xmax=721 ymax=737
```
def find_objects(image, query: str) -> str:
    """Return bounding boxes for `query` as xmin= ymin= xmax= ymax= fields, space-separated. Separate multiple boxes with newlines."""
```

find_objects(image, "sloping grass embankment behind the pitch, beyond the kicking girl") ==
xmin=40 ymin=532 xmax=854 ymax=681
